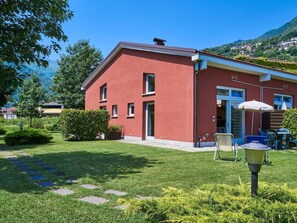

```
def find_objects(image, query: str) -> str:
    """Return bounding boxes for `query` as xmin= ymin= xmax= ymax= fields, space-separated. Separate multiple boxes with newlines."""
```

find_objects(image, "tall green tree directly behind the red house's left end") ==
xmin=52 ymin=40 xmax=102 ymax=109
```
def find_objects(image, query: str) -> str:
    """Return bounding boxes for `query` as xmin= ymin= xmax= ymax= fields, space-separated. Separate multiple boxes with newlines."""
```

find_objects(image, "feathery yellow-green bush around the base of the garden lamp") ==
xmin=118 ymin=183 xmax=297 ymax=222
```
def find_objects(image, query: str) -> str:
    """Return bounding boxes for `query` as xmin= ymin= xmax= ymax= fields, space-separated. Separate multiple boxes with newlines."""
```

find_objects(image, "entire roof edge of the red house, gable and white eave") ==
xmin=81 ymin=42 xmax=297 ymax=90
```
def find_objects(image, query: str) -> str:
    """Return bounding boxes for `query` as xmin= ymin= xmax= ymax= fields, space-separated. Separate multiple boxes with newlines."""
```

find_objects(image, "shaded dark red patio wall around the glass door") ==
xmin=197 ymin=67 xmax=297 ymax=135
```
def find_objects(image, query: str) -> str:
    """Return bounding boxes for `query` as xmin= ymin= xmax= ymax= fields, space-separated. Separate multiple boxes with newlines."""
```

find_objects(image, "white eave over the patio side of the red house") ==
xmin=192 ymin=52 xmax=297 ymax=83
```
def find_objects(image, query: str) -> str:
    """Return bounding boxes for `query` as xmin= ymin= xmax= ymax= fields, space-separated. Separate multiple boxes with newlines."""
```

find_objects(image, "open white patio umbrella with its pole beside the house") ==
xmin=237 ymin=100 xmax=274 ymax=135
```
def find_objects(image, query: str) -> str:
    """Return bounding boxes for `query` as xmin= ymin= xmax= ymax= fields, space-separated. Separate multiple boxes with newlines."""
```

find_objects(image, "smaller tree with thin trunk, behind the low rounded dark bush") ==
xmin=17 ymin=73 xmax=45 ymax=127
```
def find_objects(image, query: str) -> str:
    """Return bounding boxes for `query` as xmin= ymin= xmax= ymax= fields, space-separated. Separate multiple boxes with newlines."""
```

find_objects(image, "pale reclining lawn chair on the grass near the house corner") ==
xmin=213 ymin=133 xmax=238 ymax=162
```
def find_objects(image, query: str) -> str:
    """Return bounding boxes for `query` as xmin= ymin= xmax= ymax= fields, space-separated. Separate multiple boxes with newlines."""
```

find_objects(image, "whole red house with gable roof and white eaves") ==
xmin=82 ymin=39 xmax=297 ymax=146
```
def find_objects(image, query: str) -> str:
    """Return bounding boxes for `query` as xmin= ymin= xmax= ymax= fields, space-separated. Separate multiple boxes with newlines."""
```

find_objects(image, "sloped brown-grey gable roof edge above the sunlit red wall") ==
xmin=81 ymin=42 xmax=198 ymax=90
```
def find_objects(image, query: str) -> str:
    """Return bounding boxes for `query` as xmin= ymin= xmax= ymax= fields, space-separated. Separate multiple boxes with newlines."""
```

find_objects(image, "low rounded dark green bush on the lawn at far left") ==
xmin=4 ymin=129 xmax=53 ymax=146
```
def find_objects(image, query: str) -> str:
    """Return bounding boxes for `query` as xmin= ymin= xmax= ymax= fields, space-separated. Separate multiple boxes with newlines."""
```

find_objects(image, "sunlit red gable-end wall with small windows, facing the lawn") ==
xmin=85 ymin=49 xmax=193 ymax=142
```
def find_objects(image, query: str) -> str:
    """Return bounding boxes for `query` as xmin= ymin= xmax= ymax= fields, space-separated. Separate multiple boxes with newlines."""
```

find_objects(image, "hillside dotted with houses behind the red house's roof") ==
xmin=205 ymin=17 xmax=297 ymax=62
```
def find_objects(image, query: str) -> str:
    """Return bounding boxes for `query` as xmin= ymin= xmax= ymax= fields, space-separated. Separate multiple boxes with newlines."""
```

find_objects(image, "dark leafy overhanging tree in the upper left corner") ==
xmin=0 ymin=0 xmax=73 ymax=105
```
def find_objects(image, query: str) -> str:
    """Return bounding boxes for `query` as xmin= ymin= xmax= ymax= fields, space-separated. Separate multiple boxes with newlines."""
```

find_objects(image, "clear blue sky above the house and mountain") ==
xmin=50 ymin=0 xmax=297 ymax=59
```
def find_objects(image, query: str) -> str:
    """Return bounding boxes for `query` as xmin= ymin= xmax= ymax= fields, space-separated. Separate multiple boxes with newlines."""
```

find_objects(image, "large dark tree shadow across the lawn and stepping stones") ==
xmin=0 ymin=151 xmax=159 ymax=193
